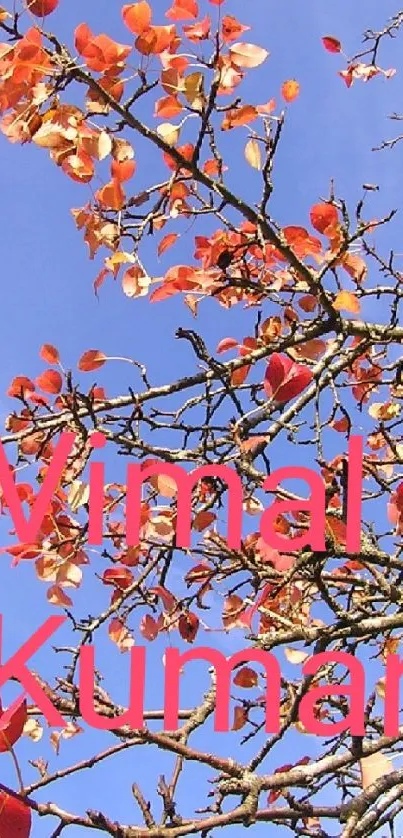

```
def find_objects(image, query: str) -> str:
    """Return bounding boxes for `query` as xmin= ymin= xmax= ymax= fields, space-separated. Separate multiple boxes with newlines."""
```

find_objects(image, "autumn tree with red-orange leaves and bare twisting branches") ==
xmin=0 ymin=0 xmax=403 ymax=838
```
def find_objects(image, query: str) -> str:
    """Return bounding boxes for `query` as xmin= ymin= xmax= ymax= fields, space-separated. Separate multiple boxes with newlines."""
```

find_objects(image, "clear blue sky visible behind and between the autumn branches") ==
xmin=0 ymin=0 xmax=403 ymax=838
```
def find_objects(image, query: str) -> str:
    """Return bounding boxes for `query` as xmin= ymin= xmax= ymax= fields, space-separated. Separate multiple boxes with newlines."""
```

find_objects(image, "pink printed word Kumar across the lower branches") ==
xmin=0 ymin=616 xmax=403 ymax=736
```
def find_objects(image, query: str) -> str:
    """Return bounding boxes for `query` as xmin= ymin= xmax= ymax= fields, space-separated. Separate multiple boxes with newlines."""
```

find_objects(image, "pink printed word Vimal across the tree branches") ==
xmin=0 ymin=431 xmax=363 ymax=553
